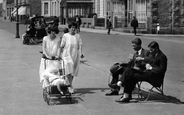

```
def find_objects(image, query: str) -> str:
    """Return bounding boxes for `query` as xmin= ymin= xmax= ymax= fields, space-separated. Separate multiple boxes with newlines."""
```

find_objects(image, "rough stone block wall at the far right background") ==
xmin=152 ymin=0 xmax=184 ymax=34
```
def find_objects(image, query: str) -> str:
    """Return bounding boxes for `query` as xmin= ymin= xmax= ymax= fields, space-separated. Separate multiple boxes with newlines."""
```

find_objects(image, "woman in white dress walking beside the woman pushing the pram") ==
xmin=59 ymin=23 xmax=83 ymax=93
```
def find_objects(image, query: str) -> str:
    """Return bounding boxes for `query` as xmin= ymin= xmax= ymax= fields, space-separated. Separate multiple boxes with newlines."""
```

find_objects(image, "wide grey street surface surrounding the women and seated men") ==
xmin=0 ymin=22 xmax=184 ymax=115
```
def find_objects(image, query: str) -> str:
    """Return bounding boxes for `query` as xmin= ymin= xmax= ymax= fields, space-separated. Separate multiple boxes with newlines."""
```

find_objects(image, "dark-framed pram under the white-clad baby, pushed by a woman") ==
xmin=40 ymin=52 xmax=72 ymax=105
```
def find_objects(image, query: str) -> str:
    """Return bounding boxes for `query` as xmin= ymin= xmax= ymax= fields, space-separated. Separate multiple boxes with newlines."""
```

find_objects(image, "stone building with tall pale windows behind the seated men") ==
xmin=106 ymin=0 xmax=184 ymax=34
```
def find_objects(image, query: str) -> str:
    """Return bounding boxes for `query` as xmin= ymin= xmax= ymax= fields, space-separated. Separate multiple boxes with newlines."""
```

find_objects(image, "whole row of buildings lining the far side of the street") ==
xmin=2 ymin=0 xmax=181 ymax=34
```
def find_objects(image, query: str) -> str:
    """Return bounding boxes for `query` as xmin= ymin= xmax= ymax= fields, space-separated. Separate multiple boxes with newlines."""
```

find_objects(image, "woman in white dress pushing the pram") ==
xmin=39 ymin=27 xmax=61 ymax=85
